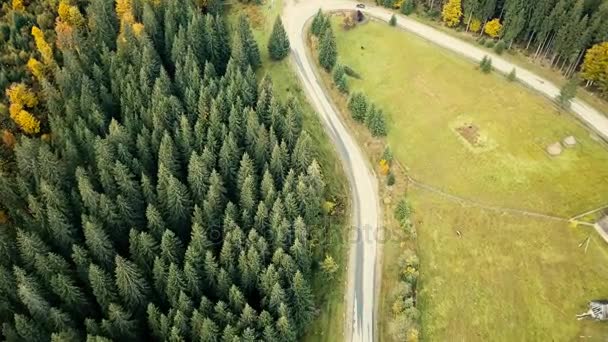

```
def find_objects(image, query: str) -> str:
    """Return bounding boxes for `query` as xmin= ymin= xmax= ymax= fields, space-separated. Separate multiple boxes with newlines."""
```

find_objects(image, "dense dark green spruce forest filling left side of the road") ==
xmin=0 ymin=0 xmax=337 ymax=341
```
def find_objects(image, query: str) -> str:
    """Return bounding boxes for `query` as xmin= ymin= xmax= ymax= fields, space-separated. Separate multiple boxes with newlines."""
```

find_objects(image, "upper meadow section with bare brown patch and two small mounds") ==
xmin=334 ymin=19 xmax=608 ymax=215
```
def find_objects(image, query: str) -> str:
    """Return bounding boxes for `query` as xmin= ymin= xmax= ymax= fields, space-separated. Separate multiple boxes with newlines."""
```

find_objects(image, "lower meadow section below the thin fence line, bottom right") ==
xmin=409 ymin=189 xmax=608 ymax=341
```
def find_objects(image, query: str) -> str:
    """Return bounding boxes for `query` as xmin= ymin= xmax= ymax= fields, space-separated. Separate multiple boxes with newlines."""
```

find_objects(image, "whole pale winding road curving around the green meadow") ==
xmin=282 ymin=0 xmax=608 ymax=342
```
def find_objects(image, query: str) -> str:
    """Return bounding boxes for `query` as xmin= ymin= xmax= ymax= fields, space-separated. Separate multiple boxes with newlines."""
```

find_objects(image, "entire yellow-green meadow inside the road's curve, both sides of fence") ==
xmin=320 ymin=14 xmax=608 ymax=340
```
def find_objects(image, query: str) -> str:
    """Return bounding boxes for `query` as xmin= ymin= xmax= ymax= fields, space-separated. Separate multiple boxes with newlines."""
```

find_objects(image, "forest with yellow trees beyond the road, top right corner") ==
xmin=379 ymin=0 xmax=608 ymax=96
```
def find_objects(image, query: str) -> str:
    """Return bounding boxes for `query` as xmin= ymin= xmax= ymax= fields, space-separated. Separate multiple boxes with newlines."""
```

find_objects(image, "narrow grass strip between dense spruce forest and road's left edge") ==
xmin=228 ymin=0 xmax=350 ymax=342
